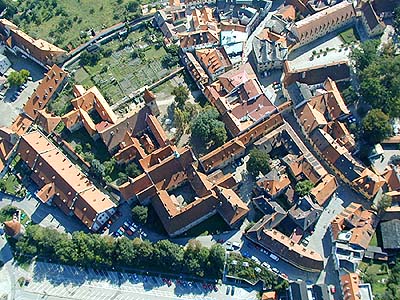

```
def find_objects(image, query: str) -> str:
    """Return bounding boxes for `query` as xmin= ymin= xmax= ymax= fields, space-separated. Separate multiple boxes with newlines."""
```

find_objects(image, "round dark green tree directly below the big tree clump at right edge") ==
xmin=362 ymin=109 xmax=392 ymax=145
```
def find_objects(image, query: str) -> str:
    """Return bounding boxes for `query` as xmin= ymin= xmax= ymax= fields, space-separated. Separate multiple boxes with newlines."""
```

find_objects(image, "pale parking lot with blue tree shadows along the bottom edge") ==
xmin=15 ymin=262 xmax=256 ymax=300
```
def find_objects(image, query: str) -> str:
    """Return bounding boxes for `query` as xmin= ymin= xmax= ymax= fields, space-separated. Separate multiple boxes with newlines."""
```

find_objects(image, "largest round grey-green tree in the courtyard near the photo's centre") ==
xmin=191 ymin=107 xmax=228 ymax=147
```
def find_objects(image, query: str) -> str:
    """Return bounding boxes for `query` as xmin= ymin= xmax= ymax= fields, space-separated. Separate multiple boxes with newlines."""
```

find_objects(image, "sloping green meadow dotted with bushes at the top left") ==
xmin=13 ymin=0 xmax=142 ymax=50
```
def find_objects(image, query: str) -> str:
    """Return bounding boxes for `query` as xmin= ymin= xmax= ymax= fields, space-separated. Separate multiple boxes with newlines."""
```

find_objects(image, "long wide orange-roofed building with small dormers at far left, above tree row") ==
xmin=18 ymin=131 xmax=115 ymax=229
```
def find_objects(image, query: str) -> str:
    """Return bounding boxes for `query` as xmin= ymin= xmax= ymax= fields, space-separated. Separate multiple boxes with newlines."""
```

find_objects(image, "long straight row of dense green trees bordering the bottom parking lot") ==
xmin=15 ymin=225 xmax=225 ymax=278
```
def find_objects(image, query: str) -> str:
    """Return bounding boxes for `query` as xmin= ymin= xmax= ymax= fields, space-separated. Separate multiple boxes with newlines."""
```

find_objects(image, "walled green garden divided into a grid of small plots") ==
xmin=70 ymin=25 xmax=172 ymax=105
